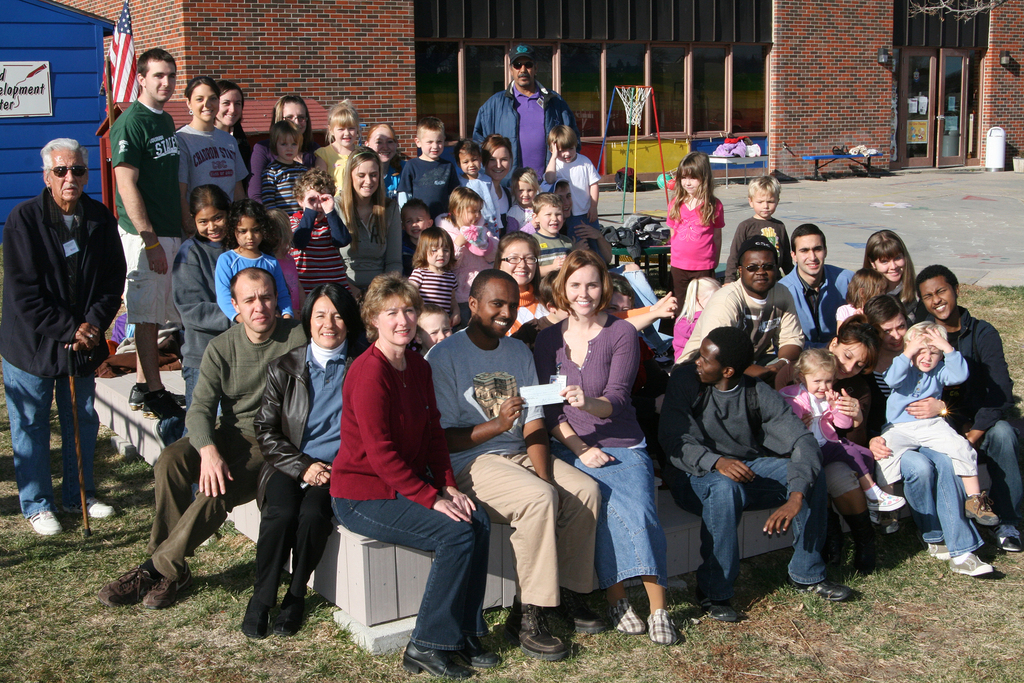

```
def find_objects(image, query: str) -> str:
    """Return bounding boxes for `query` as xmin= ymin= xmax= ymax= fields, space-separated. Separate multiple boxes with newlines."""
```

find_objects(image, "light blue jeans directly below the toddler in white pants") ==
xmin=899 ymin=449 xmax=984 ymax=557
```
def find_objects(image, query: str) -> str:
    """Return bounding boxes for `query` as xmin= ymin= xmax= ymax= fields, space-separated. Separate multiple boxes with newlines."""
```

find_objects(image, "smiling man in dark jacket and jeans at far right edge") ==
xmin=918 ymin=265 xmax=1024 ymax=553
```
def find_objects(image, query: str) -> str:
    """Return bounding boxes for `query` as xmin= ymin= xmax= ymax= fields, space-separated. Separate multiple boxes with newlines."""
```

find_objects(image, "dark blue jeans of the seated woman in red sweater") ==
xmin=331 ymin=495 xmax=490 ymax=650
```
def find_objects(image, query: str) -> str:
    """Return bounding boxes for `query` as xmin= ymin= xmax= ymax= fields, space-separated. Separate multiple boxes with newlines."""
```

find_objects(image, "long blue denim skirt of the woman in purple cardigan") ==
xmin=551 ymin=441 xmax=669 ymax=589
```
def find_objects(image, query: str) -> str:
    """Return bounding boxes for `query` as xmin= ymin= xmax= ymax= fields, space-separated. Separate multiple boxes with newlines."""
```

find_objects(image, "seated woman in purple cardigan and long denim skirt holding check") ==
xmin=534 ymin=250 xmax=682 ymax=645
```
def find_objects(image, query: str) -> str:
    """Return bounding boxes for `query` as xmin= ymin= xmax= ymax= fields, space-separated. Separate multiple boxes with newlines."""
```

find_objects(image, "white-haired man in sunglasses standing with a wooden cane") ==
xmin=0 ymin=138 xmax=126 ymax=536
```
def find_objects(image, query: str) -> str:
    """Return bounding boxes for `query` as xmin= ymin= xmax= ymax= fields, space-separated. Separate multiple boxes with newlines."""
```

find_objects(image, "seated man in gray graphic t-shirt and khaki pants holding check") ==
xmin=427 ymin=269 xmax=605 ymax=660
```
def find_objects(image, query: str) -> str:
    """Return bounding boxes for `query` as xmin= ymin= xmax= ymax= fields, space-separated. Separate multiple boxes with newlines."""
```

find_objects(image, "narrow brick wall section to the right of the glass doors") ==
xmin=981 ymin=3 xmax=1024 ymax=168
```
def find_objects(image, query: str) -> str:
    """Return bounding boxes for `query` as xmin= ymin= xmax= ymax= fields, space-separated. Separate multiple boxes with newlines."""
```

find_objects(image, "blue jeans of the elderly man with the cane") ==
xmin=3 ymin=359 xmax=99 ymax=518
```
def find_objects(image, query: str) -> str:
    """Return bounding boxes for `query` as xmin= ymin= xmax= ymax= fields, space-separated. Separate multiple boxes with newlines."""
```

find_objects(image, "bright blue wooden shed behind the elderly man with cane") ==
xmin=0 ymin=0 xmax=114 ymax=241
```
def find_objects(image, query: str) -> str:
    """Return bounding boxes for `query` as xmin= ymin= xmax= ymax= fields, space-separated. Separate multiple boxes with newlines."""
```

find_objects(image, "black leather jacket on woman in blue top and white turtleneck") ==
xmin=253 ymin=340 xmax=364 ymax=508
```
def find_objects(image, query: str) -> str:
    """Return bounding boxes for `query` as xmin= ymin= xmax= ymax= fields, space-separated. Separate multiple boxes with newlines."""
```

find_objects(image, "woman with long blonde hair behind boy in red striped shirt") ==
xmin=338 ymin=146 xmax=401 ymax=290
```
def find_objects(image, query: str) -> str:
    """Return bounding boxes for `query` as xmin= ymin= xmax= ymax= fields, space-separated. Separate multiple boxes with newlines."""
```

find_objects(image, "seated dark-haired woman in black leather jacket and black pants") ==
xmin=242 ymin=283 xmax=362 ymax=638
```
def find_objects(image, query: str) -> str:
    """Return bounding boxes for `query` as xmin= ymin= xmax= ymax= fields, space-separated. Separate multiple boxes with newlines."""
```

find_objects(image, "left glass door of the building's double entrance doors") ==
xmin=900 ymin=48 xmax=936 ymax=167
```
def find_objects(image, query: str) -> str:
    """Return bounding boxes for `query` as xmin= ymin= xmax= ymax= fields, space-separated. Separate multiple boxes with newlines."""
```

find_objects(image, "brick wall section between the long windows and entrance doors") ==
xmin=768 ymin=0 xmax=893 ymax=178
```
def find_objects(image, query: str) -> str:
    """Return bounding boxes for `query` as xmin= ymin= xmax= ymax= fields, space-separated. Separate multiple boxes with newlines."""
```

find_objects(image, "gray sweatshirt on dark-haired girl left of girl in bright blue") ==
xmin=171 ymin=237 xmax=231 ymax=368
